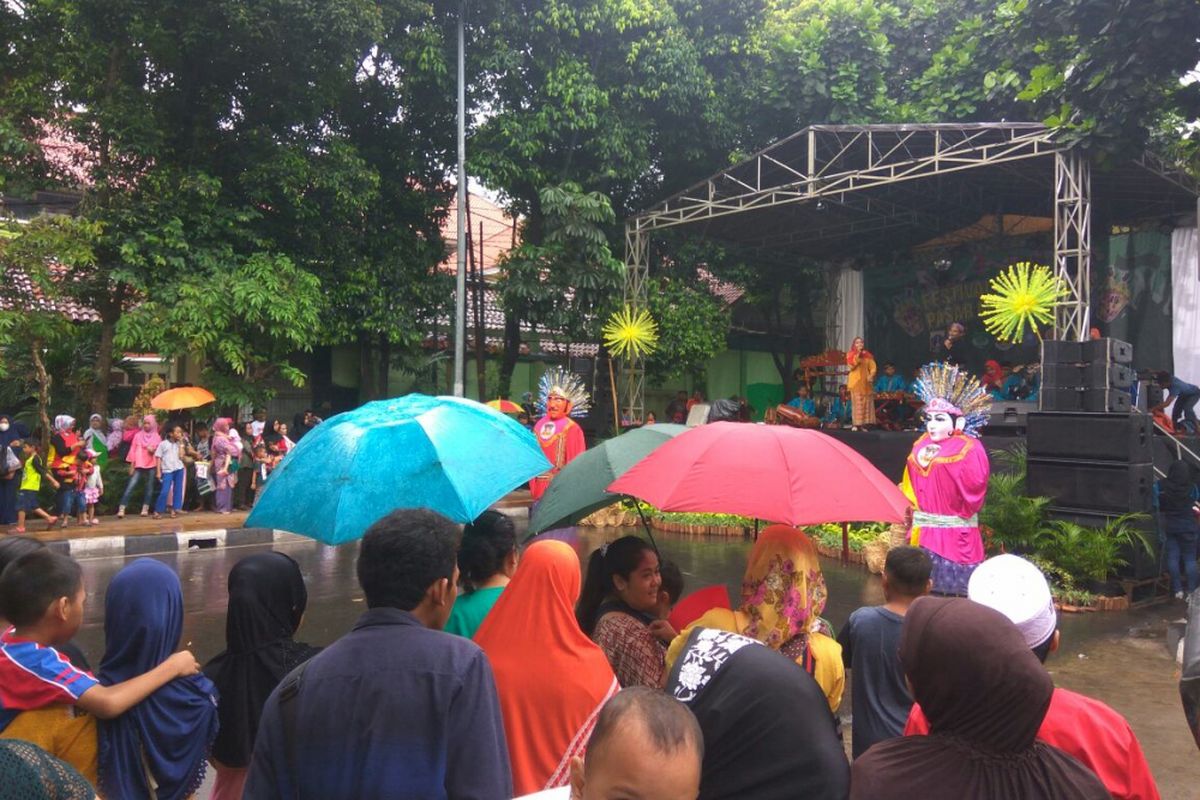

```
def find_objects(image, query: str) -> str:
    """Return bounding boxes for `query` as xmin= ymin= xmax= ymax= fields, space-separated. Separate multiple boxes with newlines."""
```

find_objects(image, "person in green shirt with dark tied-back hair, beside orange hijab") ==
xmin=444 ymin=510 xmax=517 ymax=639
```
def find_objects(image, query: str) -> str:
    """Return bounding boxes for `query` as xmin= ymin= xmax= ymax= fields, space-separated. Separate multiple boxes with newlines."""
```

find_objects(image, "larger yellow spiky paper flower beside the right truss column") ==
xmin=979 ymin=261 xmax=1067 ymax=342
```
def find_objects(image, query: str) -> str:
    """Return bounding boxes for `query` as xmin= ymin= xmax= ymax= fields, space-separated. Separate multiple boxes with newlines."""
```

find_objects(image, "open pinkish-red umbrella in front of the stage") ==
xmin=608 ymin=422 xmax=910 ymax=544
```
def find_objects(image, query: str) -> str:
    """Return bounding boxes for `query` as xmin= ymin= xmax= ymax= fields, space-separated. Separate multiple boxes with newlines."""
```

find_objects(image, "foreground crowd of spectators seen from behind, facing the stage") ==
xmin=0 ymin=510 xmax=1158 ymax=800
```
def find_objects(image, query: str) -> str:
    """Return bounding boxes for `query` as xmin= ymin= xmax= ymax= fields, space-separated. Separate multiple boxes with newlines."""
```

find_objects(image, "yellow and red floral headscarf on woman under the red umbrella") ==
xmin=742 ymin=525 xmax=828 ymax=650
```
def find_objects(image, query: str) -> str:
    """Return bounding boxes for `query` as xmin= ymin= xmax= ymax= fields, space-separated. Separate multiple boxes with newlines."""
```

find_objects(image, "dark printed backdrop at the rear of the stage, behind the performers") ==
xmin=864 ymin=237 xmax=1049 ymax=375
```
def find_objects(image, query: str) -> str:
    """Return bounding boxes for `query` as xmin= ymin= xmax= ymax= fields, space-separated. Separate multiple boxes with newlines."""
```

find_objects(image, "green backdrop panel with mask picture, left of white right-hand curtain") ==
xmin=1092 ymin=230 xmax=1180 ymax=371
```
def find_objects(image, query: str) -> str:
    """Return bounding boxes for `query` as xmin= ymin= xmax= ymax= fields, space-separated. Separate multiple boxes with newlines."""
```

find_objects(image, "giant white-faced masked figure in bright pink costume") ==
xmin=900 ymin=363 xmax=991 ymax=596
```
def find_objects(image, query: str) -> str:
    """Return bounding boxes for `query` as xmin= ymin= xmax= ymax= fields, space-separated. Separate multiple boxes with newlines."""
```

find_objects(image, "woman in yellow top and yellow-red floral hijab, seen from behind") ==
xmin=667 ymin=525 xmax=846 ymax=711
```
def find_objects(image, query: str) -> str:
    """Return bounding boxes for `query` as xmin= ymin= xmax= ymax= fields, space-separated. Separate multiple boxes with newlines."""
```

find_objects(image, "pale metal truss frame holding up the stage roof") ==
xmin=622 ymin=122 xmax=1200 ymax=420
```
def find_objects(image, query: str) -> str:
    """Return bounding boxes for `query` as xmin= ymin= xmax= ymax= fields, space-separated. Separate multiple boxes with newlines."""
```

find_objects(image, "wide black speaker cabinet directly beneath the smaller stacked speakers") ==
xmin=1025 ymin=411 xmax=1154 ymax=464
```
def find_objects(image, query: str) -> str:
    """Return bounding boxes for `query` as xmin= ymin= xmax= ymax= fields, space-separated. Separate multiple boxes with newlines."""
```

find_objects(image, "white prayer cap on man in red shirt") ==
xmin=967 ymin=553 xmax=1058 ymax=650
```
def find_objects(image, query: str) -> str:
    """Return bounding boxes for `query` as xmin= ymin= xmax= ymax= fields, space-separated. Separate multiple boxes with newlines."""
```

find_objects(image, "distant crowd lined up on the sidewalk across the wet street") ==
xmin=0 ymin=409 xmax=322 ymax=534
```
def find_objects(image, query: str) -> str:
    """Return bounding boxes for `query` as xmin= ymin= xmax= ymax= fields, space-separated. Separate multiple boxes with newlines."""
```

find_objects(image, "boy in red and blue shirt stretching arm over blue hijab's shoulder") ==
xmin=0 ymin=549 xmax=199 ymax=782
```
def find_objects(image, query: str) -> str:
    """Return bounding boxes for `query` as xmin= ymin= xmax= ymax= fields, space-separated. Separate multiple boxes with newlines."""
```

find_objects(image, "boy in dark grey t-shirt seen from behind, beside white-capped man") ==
xmin=838 ymin=547 xmax=932 ymax=758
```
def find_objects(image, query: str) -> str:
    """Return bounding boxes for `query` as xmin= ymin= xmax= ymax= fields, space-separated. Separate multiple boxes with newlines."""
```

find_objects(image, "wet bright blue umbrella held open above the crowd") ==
xmin=246 ymin=395 xmax=550 ymax=545
